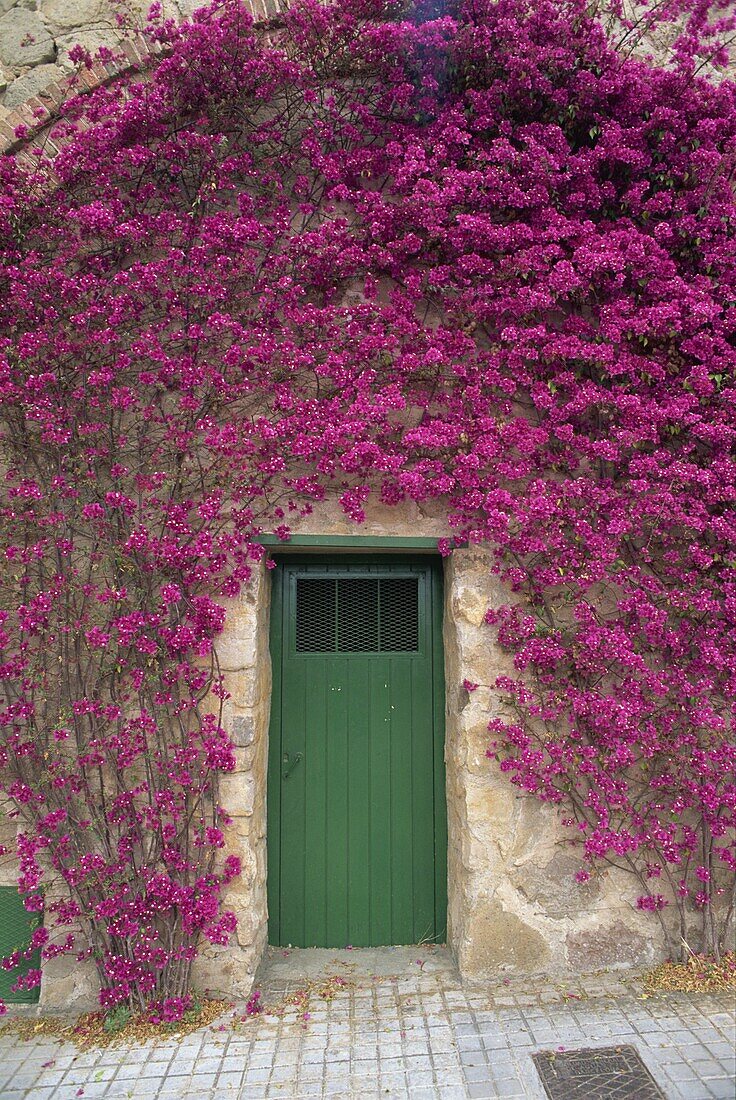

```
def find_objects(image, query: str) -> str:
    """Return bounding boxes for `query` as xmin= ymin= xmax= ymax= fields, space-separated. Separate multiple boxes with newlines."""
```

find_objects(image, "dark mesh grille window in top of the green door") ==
xmin=296 ymin=576 xmax=419 ymax=653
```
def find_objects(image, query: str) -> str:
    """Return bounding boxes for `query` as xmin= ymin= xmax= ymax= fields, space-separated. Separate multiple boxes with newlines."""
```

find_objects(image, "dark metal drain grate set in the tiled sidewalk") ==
xmin=531 ymin=1046 xmax=666 ymax=1100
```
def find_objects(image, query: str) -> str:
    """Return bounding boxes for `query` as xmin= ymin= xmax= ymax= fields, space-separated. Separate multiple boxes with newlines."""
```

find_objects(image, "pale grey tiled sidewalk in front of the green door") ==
xmin=0 ymin=947 xmax=736 ymax=1100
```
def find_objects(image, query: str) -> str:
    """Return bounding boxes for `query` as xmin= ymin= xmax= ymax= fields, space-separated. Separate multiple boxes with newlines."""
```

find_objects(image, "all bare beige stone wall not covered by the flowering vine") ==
xmin=0 ymin=0 xmax=708 ymax=1008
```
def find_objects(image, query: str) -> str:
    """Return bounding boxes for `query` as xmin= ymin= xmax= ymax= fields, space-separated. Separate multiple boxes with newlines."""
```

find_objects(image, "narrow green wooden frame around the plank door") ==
xmin=267 ymin=545 xmax=448 ymax=946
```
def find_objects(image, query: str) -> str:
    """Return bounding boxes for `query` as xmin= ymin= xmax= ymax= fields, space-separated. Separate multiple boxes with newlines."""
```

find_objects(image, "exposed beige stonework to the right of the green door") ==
xmin=435 ymin=548 xmax=658 ymax=981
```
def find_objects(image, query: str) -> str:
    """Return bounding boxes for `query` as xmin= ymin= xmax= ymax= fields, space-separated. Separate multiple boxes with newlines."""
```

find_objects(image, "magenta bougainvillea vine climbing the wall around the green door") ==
xmin=0 ymin=0 xmax=736 ymax=1020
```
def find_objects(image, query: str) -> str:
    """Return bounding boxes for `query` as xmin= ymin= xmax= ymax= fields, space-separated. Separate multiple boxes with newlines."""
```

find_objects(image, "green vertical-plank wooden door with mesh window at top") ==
xmin=268 ymin=556 xmax=447 ymax=947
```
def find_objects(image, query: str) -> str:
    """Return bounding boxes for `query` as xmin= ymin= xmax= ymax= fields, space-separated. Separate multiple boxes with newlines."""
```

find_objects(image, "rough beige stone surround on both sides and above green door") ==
xmin=188 ymin=504 xmax=658 ymax=996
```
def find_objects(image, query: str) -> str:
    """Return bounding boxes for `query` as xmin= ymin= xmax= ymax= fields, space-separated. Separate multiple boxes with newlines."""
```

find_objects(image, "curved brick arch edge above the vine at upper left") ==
xmin=0 ymin=0 xmax=289 ymax=160
